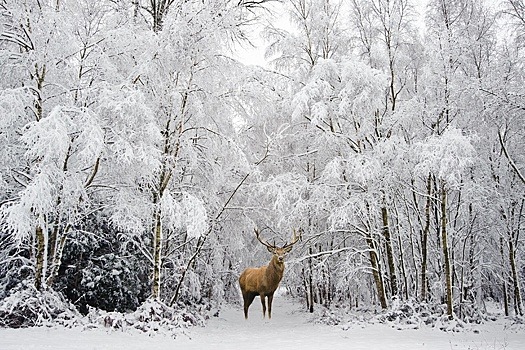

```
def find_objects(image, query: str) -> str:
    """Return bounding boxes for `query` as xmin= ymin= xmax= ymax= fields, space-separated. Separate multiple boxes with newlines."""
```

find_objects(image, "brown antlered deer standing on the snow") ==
xmin=239 ymin=228 xmax=301 ymax=319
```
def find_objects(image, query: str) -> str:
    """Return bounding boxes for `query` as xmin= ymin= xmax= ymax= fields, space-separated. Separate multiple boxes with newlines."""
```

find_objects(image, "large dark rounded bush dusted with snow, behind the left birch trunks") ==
xmin=55 ymin=225 xmax=150 ymax=315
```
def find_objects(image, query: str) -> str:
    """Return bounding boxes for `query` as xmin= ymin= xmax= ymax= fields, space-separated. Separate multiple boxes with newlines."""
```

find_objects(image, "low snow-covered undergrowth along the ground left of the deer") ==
xmin=0 ymin=288 xmax=210 ymax=337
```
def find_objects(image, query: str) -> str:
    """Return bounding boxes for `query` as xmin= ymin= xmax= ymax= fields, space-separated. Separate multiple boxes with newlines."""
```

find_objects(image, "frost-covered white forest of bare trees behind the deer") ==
xmin=0 ymin=0 xmax=525 ymax=327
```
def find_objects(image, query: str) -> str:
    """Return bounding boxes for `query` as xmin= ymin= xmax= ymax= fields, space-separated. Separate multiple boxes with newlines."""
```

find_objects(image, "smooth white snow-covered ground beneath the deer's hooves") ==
xmin=0 ymin=296 xmax=525 ymax=350
